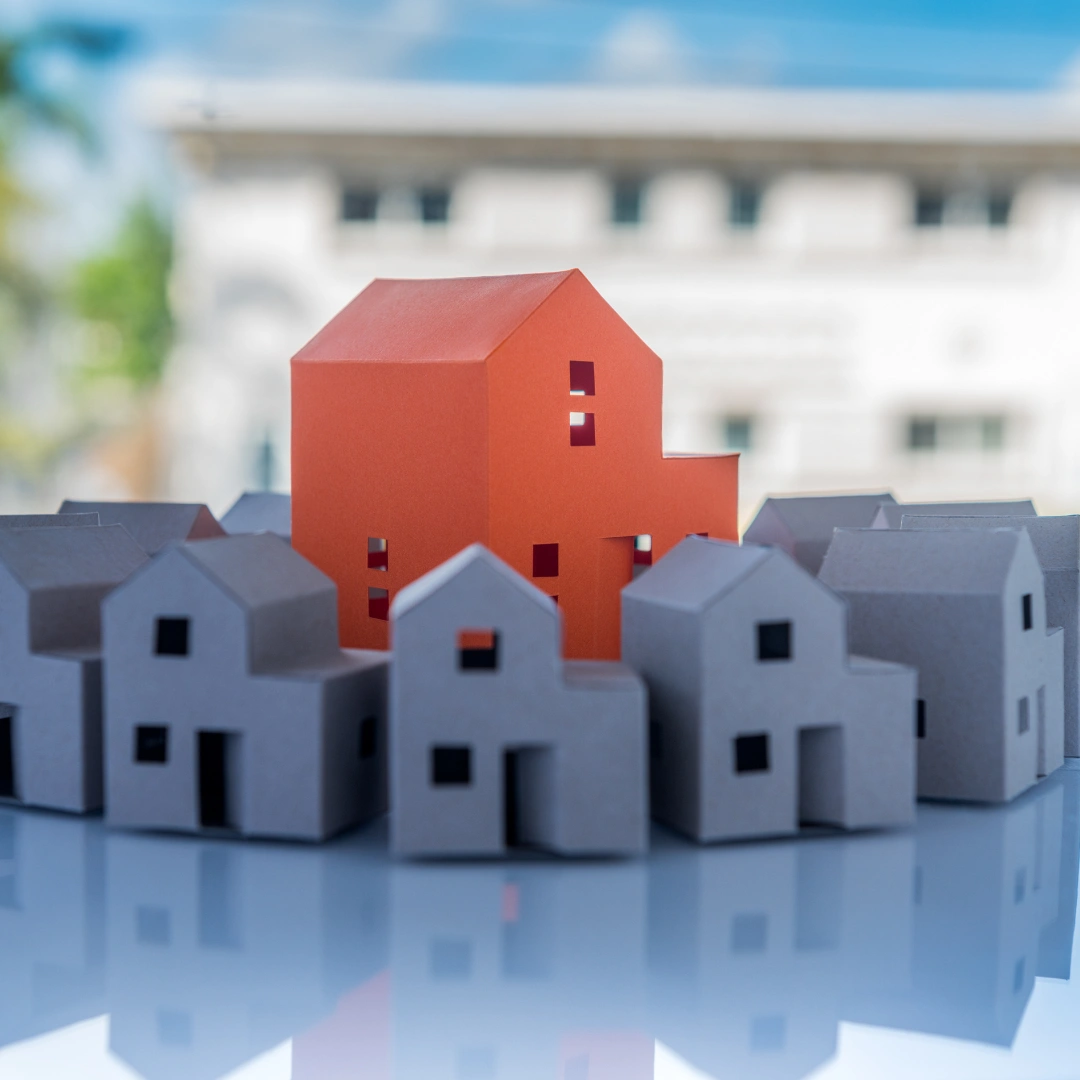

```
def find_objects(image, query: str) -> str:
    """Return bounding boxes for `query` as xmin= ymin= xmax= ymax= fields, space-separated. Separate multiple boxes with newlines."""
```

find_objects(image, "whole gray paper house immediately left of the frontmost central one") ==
xmin=103 ymin=534 xmax=388 ymax=840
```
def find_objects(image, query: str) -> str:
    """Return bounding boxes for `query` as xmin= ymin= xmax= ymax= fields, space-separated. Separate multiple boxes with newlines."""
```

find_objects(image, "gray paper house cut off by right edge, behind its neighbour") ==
xmin=901 ymin=513 xmax=1080 ymax=757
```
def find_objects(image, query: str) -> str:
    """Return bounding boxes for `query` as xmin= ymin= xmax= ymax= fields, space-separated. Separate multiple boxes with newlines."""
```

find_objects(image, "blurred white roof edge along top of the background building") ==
xmin=136 ymin=77 xmax=1080 ymax=145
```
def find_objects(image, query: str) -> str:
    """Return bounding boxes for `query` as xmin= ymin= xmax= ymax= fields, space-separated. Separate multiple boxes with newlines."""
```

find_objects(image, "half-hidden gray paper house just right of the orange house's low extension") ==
xmin=743 ymin=491 xmax=896 ymax=575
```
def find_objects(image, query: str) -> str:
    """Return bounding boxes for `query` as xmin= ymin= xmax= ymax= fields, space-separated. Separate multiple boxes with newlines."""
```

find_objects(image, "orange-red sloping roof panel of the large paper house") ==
xmin=293 ymin=270 xmax=581 ymax=362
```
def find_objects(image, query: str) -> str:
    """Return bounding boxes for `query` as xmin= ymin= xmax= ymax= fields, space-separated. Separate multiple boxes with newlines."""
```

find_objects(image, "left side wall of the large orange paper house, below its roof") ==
xmin=292 ymin=362 xmax=488 ymax=649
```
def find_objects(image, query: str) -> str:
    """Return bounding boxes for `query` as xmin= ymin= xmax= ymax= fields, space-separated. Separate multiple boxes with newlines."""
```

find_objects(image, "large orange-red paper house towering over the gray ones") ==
xmin=293 ymin=270 xmax=738 ymax=658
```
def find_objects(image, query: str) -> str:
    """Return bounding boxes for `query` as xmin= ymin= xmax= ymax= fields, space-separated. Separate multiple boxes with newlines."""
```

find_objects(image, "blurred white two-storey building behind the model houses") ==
xmin=146 ymin=82 xmax=1080 ymax=517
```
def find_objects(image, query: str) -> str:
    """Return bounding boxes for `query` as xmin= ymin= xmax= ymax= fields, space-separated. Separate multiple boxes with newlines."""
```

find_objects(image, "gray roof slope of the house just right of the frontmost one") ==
xmin=622 ymin=537 xmax=773 ymax=611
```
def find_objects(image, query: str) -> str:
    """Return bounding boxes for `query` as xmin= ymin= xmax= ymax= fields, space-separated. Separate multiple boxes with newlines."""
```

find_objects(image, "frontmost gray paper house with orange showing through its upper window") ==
xmin=390 ymin=544 xmax=648 ymax=855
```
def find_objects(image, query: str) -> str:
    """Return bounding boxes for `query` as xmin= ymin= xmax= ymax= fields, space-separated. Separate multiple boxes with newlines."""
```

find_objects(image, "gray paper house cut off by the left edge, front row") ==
xmin=0 ymin=526 xmax=146 ymax=813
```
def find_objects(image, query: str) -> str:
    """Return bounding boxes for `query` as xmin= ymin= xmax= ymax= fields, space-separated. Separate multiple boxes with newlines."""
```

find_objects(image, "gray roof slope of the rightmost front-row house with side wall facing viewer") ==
xmin=819 ymin=527 xmax=1035 ymax=595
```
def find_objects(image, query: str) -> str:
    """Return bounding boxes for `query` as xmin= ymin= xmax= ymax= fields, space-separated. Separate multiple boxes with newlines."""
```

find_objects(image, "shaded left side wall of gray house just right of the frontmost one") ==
xmin=622 ymin=594 xmax=703 ymax=836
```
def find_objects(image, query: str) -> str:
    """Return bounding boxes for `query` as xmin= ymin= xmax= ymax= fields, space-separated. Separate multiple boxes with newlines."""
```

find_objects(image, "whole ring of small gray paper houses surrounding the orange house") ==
xmin=0 ymin=495 xmax=1080 ymax=856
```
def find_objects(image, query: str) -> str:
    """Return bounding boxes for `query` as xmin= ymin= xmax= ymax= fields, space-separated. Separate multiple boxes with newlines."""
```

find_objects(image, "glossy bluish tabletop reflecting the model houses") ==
xmin=0 ymin=762 xmax=1080 ymax=1080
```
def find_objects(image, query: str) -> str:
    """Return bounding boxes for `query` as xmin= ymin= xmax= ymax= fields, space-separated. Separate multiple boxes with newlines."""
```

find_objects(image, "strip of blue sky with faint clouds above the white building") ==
xmin=10 ymin=0 xmax=1080 ymax=90
